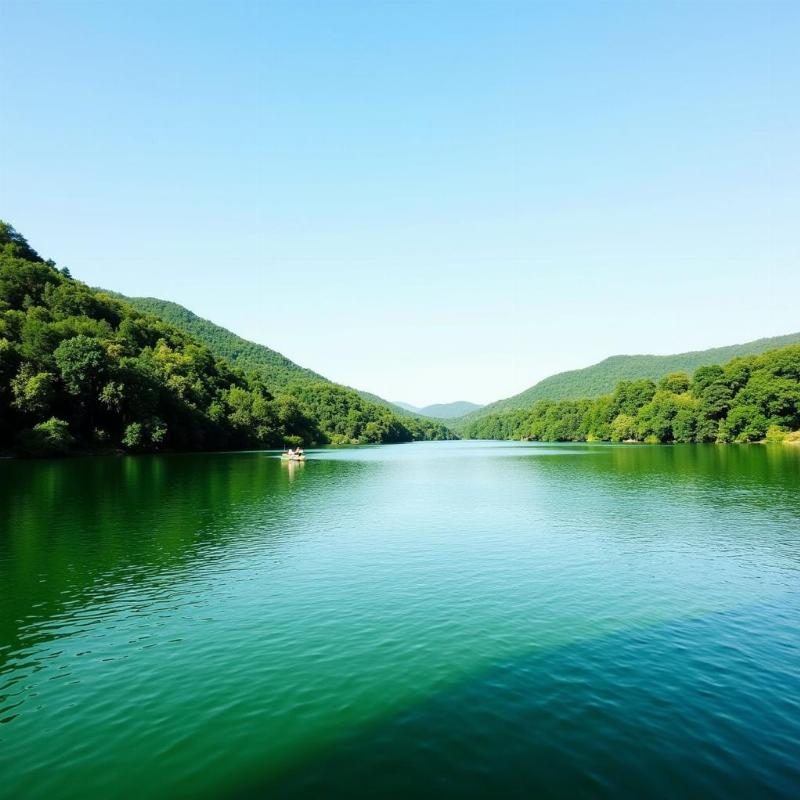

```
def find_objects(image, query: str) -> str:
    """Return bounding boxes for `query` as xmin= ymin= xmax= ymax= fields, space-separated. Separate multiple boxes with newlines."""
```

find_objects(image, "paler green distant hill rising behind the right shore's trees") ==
xmin=460 ymin=332 xmax=800 ymax=425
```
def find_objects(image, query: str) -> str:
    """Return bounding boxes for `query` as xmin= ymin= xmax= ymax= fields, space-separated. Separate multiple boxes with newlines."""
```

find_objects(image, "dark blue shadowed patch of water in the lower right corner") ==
xmin=229 ymin=594 xmax=800 ymax=800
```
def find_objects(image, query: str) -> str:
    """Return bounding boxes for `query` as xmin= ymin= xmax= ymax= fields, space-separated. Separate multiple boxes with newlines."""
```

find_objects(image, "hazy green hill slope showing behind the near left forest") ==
xmin=114 ymin=294 xmax=328 ymax=387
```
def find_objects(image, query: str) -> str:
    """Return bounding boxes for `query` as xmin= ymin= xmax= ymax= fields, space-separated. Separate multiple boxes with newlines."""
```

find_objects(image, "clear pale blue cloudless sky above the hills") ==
xmin=0 ymin=0 xmax=800 ymax=405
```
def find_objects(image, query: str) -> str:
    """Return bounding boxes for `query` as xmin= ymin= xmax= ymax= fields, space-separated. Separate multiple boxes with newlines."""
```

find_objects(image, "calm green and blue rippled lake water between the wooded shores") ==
xmin=0 ymin=442 xmax=800 ymax=800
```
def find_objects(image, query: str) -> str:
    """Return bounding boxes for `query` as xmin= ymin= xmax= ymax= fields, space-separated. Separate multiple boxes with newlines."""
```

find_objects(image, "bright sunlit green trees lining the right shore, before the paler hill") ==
xmin=464 ymin=345 xmax=800 ymax=443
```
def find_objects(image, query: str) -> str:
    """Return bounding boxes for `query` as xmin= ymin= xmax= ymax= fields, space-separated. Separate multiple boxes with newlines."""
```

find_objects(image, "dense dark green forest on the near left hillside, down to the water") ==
xmin=0 ymin=221 xmax=452 ymax=455
